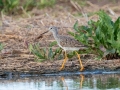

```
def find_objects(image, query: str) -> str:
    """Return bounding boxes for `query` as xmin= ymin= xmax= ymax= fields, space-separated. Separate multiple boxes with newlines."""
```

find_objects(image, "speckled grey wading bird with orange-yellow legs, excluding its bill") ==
xmin=49 ymin=26 xmax=84 ymax=71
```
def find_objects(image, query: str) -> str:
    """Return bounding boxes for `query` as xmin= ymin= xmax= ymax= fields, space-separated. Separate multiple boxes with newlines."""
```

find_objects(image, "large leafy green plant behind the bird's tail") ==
xmin=70 ymin=10 xmax=120 ymax=58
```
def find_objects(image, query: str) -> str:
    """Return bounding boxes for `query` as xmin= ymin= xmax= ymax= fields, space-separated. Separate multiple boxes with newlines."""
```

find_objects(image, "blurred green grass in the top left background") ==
xmin=0 ymin=0 xmax=56 ymax=14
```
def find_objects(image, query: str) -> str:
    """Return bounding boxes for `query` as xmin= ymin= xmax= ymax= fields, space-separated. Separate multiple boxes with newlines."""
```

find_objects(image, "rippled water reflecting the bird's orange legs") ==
xmin=0 ymin=72 xmax=120 ymax=90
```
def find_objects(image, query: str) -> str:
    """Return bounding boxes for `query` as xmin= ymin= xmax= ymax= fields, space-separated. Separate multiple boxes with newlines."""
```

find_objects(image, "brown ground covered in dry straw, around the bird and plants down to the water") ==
xmin=0 ymin=0 xmax=120 ymax=74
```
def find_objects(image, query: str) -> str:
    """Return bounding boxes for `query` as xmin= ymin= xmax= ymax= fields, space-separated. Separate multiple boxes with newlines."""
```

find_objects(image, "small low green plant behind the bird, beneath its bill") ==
xmin=29 ymin=42 xmax=62 ymax=62
